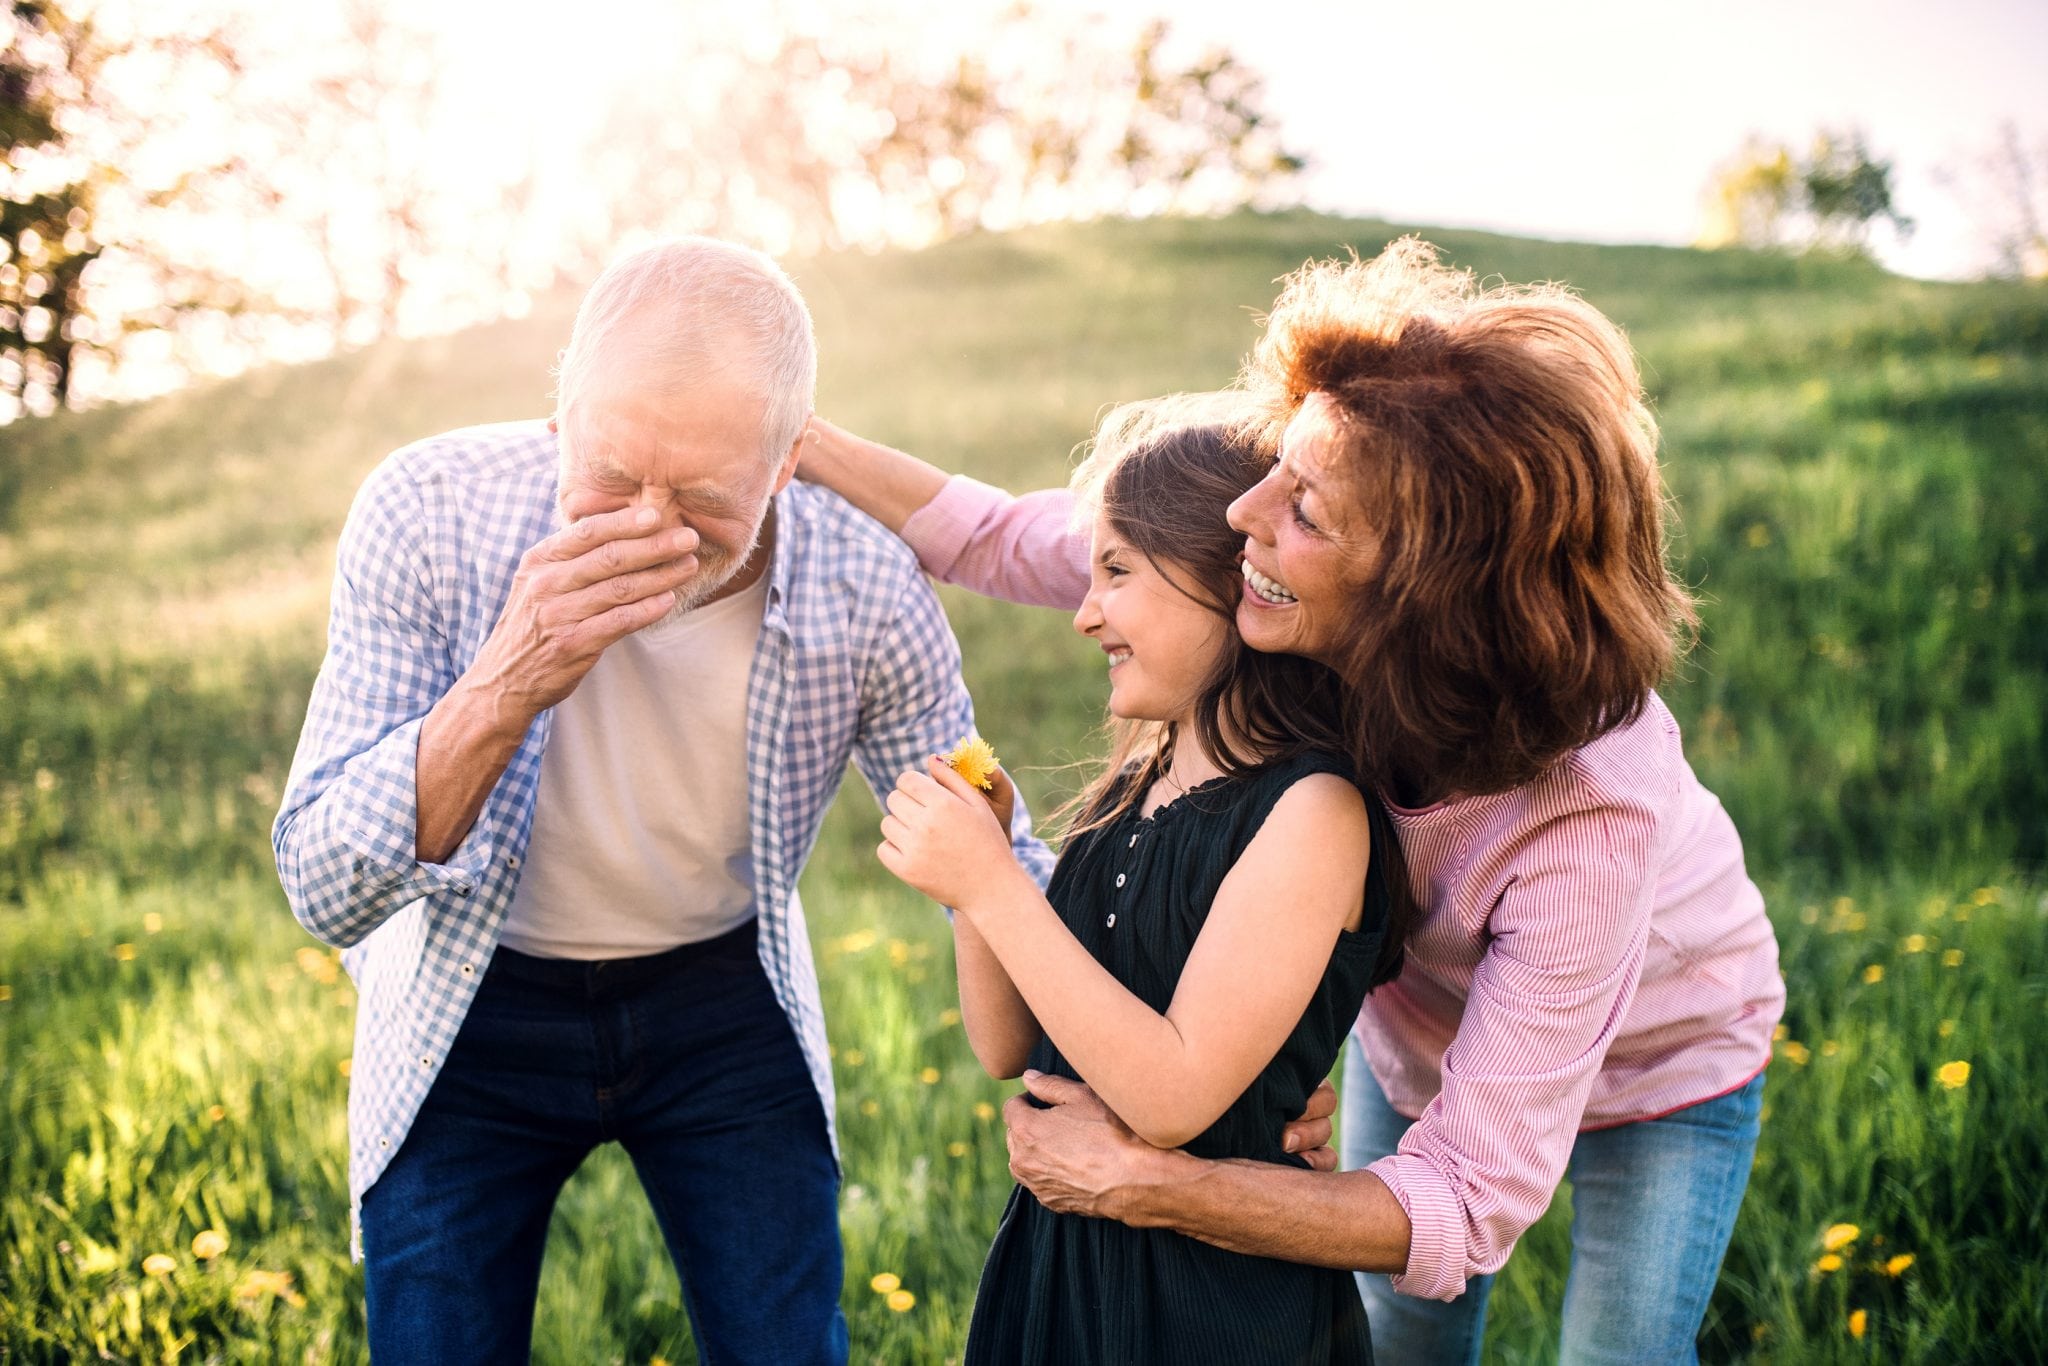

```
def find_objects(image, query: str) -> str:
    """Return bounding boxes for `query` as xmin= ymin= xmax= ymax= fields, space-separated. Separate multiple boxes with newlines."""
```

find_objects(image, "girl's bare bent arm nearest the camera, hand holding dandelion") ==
xmin=883 ymin=770 xmax=1370 ymax=1147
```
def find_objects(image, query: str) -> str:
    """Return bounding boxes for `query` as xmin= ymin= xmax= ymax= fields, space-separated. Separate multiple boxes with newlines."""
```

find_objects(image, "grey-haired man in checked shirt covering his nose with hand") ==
xmin=274 ymin=238 xmax=1051 ymax=1366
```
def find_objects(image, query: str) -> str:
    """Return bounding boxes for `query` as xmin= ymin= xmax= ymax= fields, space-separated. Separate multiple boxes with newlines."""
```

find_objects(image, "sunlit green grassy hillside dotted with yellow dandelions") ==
xmin=0 ymin=215 xmax=2048 ymax=1364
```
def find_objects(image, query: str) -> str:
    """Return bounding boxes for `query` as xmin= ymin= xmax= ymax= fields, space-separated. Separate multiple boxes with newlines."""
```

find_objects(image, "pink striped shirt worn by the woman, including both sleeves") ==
xmin=903 ymin=475 xmax=1784 ymax=1298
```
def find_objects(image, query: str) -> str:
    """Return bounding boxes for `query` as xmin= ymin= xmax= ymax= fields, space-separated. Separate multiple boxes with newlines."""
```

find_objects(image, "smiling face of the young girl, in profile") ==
xmin=1073 ymin=516 xmax=1233 ymax=721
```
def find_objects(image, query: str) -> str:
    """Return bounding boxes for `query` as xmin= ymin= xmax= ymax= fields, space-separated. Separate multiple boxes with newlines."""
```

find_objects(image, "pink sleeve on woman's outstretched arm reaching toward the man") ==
xmin=903 ymin=475 xmax=1087 ymax=612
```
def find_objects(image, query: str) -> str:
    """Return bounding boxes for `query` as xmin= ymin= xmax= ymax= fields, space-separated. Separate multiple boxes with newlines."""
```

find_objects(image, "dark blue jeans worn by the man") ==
xmin=362 ymin=922 xmax=846 ymax=1366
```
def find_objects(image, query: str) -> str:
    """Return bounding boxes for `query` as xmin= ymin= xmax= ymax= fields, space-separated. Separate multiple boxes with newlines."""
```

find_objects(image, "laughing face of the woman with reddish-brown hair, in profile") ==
xmin=1229 ymin=393 xmax=1376 ymax=664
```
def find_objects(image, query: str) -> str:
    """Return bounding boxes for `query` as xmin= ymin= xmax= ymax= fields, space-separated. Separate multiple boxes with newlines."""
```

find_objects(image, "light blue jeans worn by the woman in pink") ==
xmin=1343 ymin=1038 xmax=1763 ymax=1366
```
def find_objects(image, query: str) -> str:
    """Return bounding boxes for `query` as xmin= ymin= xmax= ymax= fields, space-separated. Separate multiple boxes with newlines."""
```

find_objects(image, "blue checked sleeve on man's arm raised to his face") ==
xmin=270 ymin=461 xmax=489 ymax=948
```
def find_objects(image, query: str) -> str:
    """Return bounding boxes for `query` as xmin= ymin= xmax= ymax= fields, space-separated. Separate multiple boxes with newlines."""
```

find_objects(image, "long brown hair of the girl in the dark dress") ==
xmin=1061 ymin=395 xmax=1417 ymax=985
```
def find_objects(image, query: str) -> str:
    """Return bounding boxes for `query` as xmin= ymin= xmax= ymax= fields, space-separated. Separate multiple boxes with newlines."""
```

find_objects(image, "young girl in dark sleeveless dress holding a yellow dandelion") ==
xmin=879 ymin=410 xmax=1405 ymax=1366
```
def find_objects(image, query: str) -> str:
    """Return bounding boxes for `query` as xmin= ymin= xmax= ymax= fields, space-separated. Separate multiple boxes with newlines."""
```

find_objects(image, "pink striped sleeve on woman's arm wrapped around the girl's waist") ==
xmin=1368 ymin=807 xmax=1655 ymax=1300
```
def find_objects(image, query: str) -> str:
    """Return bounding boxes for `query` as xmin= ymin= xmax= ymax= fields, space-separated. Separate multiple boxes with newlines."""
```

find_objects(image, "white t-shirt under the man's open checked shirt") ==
xmin=502 ymin=573 xmax=768 ymax=958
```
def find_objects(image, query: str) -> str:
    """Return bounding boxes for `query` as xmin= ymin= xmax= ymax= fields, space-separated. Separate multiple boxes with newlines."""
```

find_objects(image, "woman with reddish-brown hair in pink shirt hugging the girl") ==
xmin=805 ymin=240 xmax=1784 ymax=1362
